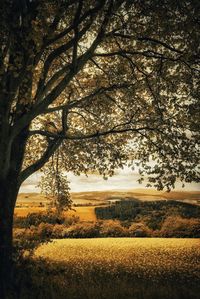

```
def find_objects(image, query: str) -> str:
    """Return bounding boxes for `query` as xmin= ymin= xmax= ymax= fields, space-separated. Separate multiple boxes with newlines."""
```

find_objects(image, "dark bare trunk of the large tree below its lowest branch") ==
xmin=0 ymin=177 xmax=19 ymax=299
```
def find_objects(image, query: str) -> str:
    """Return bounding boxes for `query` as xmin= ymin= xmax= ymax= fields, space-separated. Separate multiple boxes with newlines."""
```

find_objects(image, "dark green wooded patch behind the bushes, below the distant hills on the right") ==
xmin=95 ymin=199 xmax=200 ymax=230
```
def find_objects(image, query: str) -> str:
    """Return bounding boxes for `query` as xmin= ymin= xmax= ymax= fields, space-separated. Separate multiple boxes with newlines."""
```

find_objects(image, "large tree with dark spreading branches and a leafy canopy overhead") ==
xmin=0 ymin=0 xmax=199 ymax=296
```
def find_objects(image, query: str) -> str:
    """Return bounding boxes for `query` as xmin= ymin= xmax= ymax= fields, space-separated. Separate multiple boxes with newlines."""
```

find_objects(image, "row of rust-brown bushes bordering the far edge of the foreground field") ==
xmin=14 ymin=210 xmax=200 ymax=240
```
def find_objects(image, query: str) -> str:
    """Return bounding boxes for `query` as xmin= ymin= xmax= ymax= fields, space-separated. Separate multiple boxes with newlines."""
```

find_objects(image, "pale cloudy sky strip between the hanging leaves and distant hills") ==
xmin=20 ymin=167 xmax=200 ymax=193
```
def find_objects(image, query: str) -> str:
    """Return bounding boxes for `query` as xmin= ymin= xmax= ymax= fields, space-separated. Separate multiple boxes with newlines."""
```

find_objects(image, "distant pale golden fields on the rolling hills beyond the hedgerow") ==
xmin=15 ymin=189 xmax=200 ymax=221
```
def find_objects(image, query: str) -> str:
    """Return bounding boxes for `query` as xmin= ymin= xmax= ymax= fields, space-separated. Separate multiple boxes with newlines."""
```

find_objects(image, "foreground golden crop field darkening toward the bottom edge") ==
xmin=21 ymin=238 xmax=200 ymax=299
